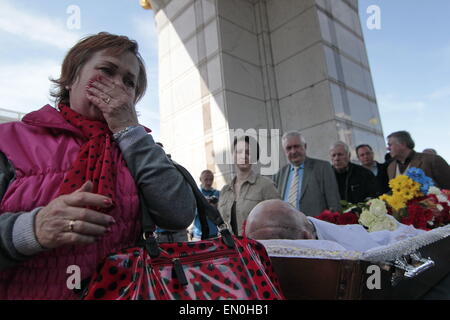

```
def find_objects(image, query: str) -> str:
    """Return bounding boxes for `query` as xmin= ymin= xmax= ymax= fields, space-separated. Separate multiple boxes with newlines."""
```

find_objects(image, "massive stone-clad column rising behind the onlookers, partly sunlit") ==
xmin=146 ymin=0 xmax=385 ymax=187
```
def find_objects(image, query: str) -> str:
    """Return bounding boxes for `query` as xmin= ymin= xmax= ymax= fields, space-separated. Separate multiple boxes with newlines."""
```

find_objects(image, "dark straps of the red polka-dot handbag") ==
xmin=139 ymin=160 xmax=235 ymax=257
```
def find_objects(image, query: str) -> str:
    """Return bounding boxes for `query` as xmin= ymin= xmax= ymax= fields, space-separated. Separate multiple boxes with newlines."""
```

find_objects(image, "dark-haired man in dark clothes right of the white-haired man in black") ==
xmin=356 ymin=144 xmax=390 ymax=194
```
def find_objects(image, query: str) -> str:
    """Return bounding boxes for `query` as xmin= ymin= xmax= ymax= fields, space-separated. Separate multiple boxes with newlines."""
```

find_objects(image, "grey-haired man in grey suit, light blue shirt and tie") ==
xmin=273 ymin=131 xmax=341 ymax=216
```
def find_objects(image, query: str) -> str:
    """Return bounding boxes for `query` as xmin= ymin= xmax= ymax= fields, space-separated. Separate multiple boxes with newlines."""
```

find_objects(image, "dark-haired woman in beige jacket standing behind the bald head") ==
xmin=219 ymin=136 xmax=280 ymax=235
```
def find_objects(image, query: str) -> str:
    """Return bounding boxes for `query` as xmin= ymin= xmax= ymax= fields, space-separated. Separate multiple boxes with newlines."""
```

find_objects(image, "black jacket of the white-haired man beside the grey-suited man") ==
xmin=334 ymin=163 xmax=380 ymax=203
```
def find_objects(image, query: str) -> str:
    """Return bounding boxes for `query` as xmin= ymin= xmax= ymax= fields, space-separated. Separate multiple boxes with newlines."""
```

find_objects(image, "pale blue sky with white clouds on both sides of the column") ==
xmin=0 ymin=0 xmax=450 ymax=161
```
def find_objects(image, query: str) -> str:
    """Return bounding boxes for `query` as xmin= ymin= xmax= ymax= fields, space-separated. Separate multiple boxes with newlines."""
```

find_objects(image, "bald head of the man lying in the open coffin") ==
xmin=245 ymin=200 xmax=315 ymax=240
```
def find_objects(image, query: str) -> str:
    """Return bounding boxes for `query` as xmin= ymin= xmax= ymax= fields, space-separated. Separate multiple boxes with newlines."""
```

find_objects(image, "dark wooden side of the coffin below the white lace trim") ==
xmin=270 ymin=237 xmax=450 ymax=300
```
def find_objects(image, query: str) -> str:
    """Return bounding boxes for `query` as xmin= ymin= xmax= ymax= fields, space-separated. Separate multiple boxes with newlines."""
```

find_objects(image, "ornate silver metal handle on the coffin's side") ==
xmin=391 ymin=253 xmax=435 ymax=286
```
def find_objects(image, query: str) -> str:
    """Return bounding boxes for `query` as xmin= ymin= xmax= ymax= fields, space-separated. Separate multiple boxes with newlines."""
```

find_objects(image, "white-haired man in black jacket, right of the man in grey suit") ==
xmin=330 ymin=141 xmax=381 ymax=203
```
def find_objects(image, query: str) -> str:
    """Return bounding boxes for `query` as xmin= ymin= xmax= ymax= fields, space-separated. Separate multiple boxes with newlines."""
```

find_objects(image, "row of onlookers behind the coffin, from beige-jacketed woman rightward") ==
xmin=192 ymin=131 xmax=450 ymax=239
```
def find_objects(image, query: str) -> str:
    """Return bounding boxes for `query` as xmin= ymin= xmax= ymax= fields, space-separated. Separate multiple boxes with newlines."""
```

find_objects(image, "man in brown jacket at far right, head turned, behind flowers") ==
xmin=387 ymin=131 xmax=450 ymax=189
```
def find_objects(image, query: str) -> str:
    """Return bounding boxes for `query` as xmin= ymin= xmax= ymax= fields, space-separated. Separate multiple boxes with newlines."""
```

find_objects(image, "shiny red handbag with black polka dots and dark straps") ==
xmin=84 ymin=164 xmax=284 ymax=300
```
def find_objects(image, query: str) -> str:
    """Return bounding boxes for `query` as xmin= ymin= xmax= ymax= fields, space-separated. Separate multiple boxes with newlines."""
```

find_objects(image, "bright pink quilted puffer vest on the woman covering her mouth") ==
xmin=0 ymin=105 xmax=141 ymax=299
